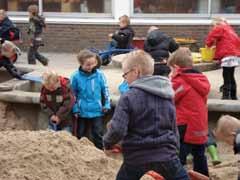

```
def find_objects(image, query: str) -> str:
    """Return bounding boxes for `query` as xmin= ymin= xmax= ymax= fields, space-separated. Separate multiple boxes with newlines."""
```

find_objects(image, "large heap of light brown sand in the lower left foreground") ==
xmin=0 ymin=131 xmax=121 ymax=180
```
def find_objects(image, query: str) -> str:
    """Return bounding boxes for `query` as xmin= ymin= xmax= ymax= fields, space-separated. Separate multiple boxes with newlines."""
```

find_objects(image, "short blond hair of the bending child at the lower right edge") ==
xmin=215 ymin=115 xmax=240 ymax=138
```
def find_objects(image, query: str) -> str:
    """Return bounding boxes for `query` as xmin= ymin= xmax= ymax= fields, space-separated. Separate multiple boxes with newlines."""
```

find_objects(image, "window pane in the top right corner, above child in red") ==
xmin=212 ymin=0 xmax=240 ymax=14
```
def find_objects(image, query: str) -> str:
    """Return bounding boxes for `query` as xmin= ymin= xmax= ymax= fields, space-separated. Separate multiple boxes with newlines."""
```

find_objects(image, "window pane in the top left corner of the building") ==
xmin=0 ymin=0 xmax=38 ymax=11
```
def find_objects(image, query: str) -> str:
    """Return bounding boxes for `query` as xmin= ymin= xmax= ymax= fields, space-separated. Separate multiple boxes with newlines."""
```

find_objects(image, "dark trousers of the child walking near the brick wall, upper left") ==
xmin=28 ymin=43 xmax=48 ymax=66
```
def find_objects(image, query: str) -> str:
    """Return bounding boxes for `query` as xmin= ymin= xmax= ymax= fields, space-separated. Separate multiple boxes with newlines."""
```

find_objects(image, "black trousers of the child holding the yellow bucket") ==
xmin=222 ymin=67 xmax=237 ymax=99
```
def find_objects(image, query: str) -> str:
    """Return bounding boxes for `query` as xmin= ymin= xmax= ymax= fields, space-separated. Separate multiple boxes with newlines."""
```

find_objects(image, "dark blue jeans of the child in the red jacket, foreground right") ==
xmin=179 ymin=143 xmax=209 ymax=176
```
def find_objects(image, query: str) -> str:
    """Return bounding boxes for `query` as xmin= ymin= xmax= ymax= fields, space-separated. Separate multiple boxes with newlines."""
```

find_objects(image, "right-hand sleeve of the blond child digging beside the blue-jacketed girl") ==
xmin=56 ymin=84 xmax=75 ymax=121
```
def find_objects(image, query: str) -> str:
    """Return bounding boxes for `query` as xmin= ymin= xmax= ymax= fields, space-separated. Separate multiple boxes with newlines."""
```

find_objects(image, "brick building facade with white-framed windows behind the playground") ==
xmin=0 ymin=0 xmax=240 ymax=52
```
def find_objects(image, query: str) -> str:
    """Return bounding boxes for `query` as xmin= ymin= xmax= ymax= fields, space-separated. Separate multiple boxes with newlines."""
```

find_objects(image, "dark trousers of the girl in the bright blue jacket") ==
xmin=78 ymin=117 xmax=103 ymax=149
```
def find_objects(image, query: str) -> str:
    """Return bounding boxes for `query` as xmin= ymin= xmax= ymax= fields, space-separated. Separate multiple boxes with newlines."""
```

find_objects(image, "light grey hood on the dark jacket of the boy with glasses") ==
xmin=130 ymin=76 xmax=174 ymax=99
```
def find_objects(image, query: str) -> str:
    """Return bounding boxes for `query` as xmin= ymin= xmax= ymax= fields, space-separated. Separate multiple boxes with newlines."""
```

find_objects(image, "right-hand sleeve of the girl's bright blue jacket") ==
xmin=101 ymin=73 xmax=111 ymax=109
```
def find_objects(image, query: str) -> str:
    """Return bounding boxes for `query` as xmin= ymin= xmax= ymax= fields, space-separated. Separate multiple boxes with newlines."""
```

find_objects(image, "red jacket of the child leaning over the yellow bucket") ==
xmin=205 ymin=23 xmax=240 ymax=61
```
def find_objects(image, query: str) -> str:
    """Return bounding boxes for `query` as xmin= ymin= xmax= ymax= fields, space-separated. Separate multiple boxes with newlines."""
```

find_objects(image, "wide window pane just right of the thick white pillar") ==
xmin=134 ymin=0 xmax=208 ymax=14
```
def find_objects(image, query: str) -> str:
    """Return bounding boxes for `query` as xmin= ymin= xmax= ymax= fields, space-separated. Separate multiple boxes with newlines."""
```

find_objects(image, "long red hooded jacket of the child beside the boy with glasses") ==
xmin=172 ymin=68 xmax=210 ymax=144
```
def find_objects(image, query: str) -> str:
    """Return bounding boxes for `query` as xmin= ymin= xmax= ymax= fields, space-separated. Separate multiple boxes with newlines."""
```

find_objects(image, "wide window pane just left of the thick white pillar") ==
xmin=43 ymin=0 xmax=112 ymax=13
